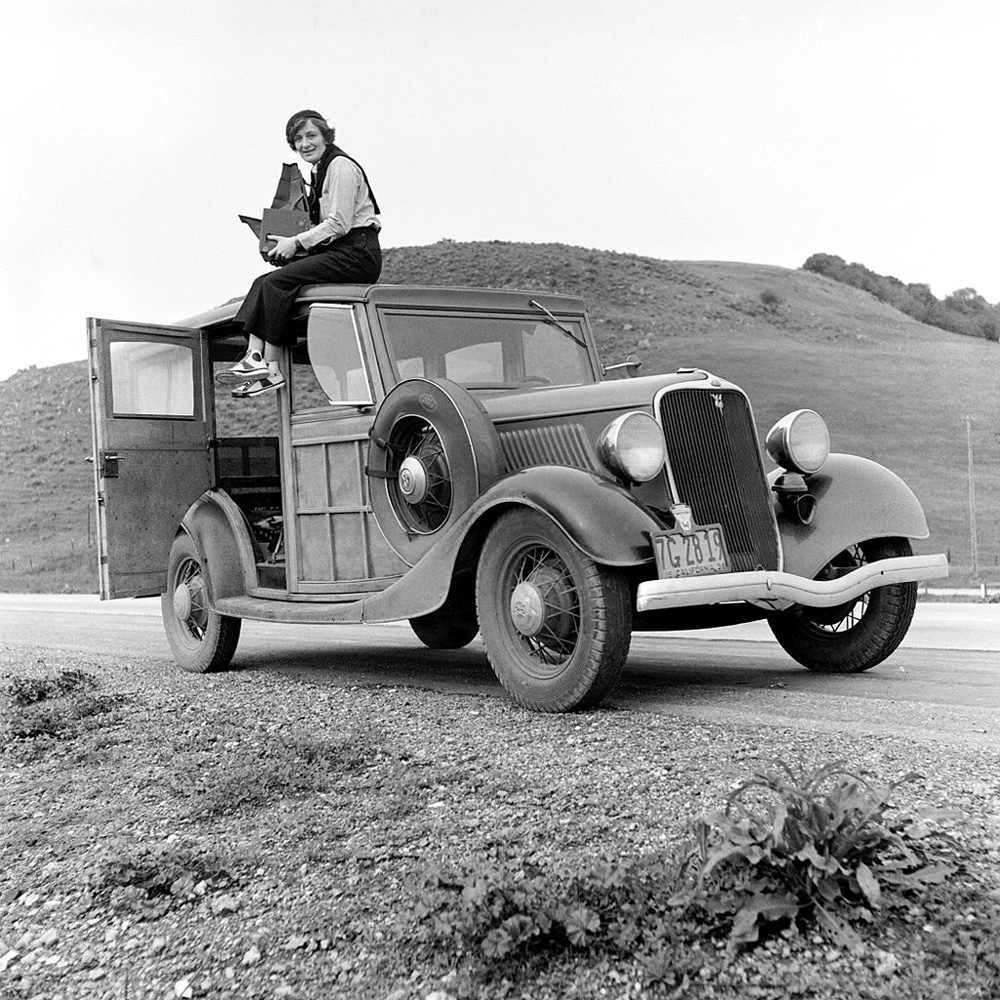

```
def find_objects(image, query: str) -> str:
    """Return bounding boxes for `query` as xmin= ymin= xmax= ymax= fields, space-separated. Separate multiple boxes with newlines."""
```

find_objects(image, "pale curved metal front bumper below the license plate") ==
xmin=636 ymin=553 xmax=948 ymax=611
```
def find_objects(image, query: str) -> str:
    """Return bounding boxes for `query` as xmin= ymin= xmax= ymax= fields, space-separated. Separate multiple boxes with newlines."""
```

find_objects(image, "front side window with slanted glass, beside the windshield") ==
xmin=292 ymin=305 xmax=373 ymax=413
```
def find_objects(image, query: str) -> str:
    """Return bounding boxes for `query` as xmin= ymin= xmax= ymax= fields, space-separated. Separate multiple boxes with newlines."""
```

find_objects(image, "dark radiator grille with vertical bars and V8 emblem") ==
xmin=660 ymin=389 xmax=779 ymax=572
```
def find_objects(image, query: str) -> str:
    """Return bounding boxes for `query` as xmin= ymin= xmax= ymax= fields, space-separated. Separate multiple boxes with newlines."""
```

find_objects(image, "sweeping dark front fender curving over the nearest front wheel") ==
xmin=363 ymin=466 xmax=664 ymax=621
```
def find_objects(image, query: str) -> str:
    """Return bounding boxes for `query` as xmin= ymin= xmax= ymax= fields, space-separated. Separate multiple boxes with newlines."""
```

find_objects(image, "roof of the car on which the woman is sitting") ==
xmin=176 ymin=284 xmax=584 ymax=329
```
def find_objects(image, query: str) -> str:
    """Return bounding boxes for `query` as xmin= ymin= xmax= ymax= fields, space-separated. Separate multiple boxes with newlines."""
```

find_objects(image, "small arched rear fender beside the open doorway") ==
xmin=181 ymin=490 xmax=257 ymax=607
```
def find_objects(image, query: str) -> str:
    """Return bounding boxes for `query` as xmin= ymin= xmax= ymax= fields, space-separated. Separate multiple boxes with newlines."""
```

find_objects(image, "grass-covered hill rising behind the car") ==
xmin=0 ymin=240 xmax=1000 ymax=592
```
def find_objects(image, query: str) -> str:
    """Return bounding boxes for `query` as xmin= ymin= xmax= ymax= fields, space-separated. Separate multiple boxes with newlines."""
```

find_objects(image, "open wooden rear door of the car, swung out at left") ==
xmin=87 ymin=319 xmax=215 ymax=600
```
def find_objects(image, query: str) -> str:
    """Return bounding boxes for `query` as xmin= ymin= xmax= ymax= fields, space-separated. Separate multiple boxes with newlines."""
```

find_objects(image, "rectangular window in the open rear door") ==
xmin=108 ymin=340 xmax=195 ymax=419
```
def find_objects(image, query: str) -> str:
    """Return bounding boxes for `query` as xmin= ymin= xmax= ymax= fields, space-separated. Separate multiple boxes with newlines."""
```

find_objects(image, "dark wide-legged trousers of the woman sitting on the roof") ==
xmin=236 ymin=226 xmax=382 ymax=345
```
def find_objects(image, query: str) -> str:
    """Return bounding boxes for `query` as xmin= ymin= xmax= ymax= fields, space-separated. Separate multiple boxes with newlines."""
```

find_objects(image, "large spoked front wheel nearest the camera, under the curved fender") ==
xmin=476 ymin=509 xmax=632 ymax=712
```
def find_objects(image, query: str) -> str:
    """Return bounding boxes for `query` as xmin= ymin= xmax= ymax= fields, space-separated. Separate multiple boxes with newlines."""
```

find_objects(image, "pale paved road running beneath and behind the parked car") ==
xmin=0 ymin=594 xmax=1000 ymax=749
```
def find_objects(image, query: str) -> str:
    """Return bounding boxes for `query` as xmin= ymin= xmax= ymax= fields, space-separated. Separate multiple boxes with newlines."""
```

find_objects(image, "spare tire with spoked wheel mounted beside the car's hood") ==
xmin=366 ymin=378 xmax=504 ymax=566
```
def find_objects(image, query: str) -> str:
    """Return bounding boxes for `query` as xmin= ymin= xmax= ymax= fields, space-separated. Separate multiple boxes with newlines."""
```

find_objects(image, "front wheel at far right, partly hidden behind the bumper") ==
xmin=768 ymin=538 xmax=917 ymax=674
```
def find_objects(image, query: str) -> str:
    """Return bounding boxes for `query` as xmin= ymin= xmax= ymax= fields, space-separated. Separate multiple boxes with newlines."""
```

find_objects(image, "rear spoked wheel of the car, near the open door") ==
xmin=160 ymin=534 xmax=243 ymax=674
